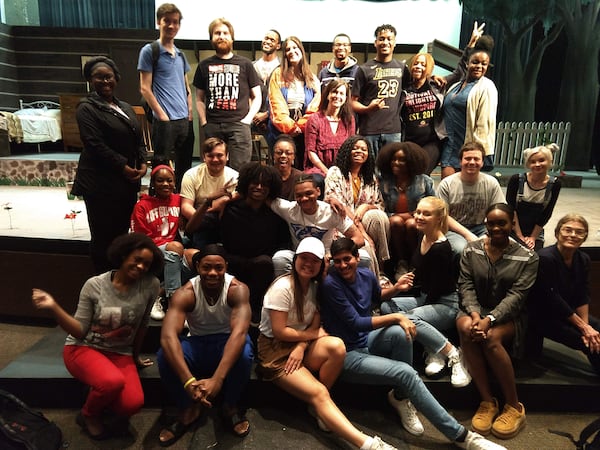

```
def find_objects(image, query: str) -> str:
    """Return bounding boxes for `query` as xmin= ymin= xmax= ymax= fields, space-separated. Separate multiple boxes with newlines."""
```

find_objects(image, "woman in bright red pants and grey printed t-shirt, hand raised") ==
xmin=32 ymin=233 xmax=163 ymax=440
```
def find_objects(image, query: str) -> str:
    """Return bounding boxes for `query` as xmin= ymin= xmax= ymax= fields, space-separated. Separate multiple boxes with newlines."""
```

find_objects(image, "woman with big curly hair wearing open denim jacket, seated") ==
xmin=375 ymin=142 xmax=435 ymax=279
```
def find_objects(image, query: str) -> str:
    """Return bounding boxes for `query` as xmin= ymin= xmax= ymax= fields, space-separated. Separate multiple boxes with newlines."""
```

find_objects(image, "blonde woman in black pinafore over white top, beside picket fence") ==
xmin=506 ymin=144 xmax=561 ymax=251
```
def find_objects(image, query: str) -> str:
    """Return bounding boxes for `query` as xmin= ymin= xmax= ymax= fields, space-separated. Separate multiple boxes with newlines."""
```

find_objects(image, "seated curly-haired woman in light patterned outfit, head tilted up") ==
xmin=325 ymin=134 xmax=390 ymax=276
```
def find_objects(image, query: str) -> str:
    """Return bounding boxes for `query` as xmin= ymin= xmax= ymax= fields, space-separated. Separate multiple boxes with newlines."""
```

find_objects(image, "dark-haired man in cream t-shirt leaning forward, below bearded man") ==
xmin=181 ymin=137 xmax=238 ymax=248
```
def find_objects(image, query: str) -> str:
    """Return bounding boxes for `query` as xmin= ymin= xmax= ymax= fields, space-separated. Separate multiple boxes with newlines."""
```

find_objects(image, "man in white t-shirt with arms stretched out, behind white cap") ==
xmin=270 ymin=174 xmax=371 ymax=276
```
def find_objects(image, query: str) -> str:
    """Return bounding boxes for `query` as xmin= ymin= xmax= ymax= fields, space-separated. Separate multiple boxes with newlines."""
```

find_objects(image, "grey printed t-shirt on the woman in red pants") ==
xmin=65 ymin=271 xmax=160 ymax=355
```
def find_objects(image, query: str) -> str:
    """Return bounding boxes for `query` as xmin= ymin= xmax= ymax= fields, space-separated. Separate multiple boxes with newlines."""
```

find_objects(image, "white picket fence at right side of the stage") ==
xmin=494 ymin=122 xmax=571 ymax=170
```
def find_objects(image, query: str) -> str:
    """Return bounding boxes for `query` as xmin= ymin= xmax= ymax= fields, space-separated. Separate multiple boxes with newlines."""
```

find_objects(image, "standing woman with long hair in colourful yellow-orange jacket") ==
xmin=266 ymin=36 xmax=321 ymax=170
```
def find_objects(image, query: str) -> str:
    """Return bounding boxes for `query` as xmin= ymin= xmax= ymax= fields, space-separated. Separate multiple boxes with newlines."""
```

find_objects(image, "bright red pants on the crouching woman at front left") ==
xmin=63 ymin=345 xmax=144 ymax=417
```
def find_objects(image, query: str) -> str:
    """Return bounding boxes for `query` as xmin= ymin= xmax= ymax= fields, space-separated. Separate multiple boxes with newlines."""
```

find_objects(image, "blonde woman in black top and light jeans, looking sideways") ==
xmin=381 ymin=196 xmax=471 ymax=387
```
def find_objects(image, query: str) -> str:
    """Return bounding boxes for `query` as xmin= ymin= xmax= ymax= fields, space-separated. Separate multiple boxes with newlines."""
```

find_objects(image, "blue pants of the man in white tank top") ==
xmin=156 ymin=334 xmax=254 ymax=409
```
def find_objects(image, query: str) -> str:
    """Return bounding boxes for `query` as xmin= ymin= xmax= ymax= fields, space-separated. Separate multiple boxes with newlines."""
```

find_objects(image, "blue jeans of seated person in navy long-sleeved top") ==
xmin=341 ymin=325 xmax=465 ymax=441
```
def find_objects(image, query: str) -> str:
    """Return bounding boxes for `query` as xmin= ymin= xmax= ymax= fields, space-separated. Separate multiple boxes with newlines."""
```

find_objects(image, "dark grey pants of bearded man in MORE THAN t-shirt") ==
xmin=204 ymin=122 xmax=252 ymax=171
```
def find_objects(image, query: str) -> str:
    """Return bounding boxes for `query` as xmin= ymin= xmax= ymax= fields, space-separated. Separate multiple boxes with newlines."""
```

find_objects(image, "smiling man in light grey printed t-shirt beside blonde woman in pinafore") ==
xmin=437 ymin=142 xmax=506 ymax=255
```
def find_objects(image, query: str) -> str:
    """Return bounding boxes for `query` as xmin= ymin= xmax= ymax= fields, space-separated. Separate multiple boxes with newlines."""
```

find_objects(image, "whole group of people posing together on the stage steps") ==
xmin=42 ymin=4 xmax=600 ymax=449
